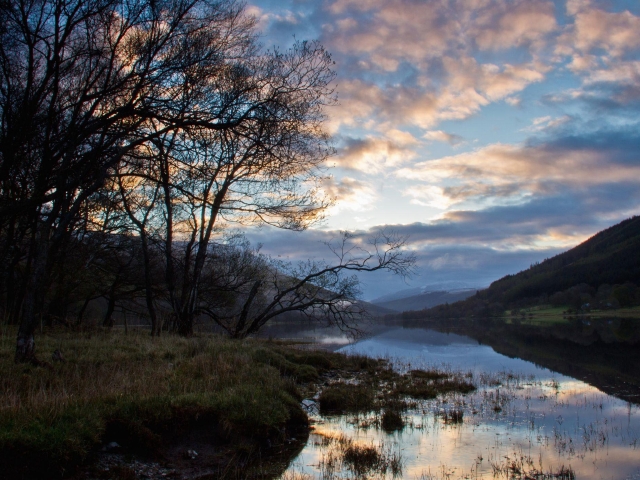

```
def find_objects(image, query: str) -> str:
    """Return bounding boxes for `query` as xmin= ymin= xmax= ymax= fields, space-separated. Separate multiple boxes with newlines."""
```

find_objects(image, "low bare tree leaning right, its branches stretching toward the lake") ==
xmin=200 ymin=231 xmax=415 ymax=338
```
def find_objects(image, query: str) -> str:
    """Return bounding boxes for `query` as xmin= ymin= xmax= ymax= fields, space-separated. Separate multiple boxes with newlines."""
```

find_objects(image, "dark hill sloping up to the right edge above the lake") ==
xmin=405 ymin=216 xmax=640 ymax=316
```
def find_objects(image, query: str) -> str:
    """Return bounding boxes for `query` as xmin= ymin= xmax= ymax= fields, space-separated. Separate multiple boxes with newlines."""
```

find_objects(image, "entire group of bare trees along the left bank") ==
xmin=0 ymin=0 xmax=412 ymax=361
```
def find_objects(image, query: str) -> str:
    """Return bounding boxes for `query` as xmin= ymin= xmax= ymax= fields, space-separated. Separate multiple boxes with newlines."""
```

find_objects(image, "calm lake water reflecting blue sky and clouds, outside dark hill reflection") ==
xmin=282 ymin=328 xmax=640 ymax=480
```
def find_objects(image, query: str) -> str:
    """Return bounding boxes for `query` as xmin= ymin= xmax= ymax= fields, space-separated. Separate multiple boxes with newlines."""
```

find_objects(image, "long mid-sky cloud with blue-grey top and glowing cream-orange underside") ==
xmin=396 ymin=124 xmax=640 ymax=209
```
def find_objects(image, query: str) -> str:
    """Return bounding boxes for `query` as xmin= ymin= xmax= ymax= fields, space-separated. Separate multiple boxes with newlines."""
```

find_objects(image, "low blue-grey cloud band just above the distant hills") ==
xmin=242 ymin=198 xmax=624 ymax=299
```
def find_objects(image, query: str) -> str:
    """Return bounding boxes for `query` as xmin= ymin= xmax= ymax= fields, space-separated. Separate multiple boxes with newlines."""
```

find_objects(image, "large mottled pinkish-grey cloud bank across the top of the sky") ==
xmin=251 ymin=0 xmax=640 ymax=133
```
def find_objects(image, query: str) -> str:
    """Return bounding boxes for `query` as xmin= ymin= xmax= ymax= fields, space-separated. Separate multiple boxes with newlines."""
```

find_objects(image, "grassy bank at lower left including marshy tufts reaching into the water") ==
xmin=0 ymin=327 xmax=480 ymax=479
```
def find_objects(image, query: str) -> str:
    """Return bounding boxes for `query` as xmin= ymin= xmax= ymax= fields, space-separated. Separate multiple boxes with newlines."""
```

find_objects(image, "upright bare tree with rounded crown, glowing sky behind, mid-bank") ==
xmin=115 ymin=42 xmax=334 ymax=335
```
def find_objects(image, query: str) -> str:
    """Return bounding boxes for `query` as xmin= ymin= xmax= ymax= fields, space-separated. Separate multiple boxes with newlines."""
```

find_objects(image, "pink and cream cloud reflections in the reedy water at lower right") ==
xmin=296 ymin=381 xmax=640 ymax=480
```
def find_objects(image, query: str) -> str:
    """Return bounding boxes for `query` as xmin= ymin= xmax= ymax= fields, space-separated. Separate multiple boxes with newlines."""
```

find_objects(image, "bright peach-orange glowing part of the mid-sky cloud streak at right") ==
xmin=396 ymin=139 xmax=640 ymax=208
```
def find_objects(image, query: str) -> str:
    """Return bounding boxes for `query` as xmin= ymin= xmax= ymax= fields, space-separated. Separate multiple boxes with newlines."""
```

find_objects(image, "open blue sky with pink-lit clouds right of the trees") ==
xmin=247 ymin=0 xmax=640 ymax=299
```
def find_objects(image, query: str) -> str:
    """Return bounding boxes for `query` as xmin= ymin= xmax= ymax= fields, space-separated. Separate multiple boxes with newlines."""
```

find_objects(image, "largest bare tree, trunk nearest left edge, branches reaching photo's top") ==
xmin=0 ymin=0 xmax=254 ymax=361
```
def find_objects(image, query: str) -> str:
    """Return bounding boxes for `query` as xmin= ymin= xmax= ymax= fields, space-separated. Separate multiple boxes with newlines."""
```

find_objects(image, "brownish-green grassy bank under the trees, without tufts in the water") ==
xmin=0 ymin=328 xmax=360 ymax=478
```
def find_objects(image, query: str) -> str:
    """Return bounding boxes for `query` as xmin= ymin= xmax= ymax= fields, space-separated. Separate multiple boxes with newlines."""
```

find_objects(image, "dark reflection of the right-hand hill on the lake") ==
xmin=403 ymin=317 xmax=640 ymax=403
